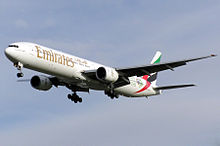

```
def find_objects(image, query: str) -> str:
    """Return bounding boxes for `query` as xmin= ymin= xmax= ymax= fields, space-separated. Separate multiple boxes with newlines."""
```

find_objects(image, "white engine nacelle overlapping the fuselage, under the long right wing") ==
xmin=96 ymin=67 xmax=119 ymax=83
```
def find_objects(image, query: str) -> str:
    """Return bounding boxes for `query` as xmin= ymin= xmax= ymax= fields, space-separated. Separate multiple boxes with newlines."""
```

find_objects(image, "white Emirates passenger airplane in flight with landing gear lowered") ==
xmin=4 ymin=42 xmax=216 ymax=103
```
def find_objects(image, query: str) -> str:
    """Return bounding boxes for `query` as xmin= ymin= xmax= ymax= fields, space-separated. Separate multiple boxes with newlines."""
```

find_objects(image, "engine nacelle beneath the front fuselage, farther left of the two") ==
xmin=30 ymin=75 xmax=53 ymax=91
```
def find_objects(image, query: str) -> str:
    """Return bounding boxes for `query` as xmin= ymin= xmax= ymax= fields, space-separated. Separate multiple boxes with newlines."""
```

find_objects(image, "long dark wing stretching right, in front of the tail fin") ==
xmin=116 ymin=55 xmax=216 ymax=77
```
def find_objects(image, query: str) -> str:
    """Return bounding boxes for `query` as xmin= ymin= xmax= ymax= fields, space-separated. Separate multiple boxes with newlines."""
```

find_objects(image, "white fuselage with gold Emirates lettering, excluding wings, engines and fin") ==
xmin=5 ymin=42 xmax=160 ymax=97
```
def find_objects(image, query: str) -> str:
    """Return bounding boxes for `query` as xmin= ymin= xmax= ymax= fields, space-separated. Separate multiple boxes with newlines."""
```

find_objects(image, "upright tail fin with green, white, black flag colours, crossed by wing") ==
xmin=148 ymin=51 xmax=162 ymax=87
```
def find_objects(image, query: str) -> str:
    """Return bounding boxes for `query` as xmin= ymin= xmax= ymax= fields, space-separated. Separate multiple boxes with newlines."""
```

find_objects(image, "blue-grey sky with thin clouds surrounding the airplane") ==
xmin=0 ymin=0 xmax=220 ymax=146
